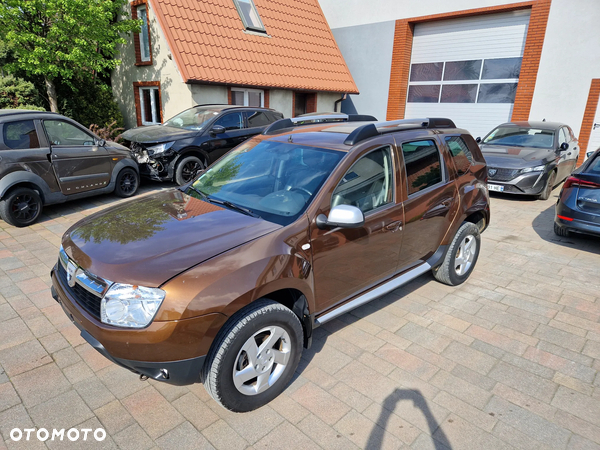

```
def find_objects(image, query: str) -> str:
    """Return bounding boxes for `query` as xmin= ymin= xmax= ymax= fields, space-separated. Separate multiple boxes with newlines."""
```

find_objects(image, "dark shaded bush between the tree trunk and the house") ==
xmin=56 ymin=79 xmax=124 ymax=128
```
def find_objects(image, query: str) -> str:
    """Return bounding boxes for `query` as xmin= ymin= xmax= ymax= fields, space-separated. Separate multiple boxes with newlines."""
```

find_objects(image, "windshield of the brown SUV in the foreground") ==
xmin=187 ymin=141 xmax=345 ymax=225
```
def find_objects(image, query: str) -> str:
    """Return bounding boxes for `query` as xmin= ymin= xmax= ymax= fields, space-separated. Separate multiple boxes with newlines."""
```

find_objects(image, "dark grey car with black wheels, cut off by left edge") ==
xmin=0 ymin=109 xmax=139 ymax=227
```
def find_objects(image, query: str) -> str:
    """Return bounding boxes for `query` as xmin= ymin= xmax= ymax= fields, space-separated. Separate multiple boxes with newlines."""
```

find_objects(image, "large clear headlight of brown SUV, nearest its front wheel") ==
xmin=100 ymin=283 xmax=165 ymax=328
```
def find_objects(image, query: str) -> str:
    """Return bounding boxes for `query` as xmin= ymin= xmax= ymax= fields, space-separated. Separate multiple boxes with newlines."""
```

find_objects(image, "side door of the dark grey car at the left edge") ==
xmin=42 ymin=119 xmax=111 ymax=195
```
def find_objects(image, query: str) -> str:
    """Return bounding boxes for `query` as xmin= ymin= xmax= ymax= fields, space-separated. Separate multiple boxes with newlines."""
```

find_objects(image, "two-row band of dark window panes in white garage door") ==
xmin=407 ymin=58 xmax=522 ymax=103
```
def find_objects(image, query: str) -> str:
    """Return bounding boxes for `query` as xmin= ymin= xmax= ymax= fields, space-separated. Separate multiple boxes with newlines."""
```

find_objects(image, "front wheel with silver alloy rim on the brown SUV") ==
xmin=202 ymin=299 xmax=303 ymax=412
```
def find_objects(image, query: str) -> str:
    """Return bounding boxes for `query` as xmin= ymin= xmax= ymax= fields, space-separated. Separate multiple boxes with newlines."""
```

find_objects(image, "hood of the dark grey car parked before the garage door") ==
xmin=480 ymin=144 xmax=556 ymax=169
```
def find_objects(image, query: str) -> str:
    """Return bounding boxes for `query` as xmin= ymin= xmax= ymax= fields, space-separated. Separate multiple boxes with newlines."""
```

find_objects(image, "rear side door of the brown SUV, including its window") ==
xmin=397 ymin=134 xmax=460 ymax=271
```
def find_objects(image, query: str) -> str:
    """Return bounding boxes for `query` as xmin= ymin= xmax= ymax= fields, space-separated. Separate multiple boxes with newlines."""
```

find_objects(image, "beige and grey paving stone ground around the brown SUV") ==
xmin=0 ymin=184 xmax=600 ymax=450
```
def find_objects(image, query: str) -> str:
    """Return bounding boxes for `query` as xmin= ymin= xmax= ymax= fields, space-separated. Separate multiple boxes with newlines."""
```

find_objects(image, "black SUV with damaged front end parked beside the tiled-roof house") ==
xmin=123 ymin=105 xmax=283 ymax=185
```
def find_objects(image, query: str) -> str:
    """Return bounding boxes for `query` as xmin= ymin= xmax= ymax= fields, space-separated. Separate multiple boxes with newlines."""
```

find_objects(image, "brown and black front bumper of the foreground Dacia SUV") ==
xmin=51 ymin=267 xmax=226 ymax=385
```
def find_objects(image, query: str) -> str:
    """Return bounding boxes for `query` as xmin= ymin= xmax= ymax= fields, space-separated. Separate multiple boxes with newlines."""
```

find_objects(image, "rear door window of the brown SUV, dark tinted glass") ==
xmin=402 ymin=140 xmax=442 ymax=195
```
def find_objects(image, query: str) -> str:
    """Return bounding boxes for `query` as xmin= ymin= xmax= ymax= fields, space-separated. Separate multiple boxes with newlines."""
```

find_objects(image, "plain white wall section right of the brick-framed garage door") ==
xmin=529 ymin=0 xmax=600 ymax=136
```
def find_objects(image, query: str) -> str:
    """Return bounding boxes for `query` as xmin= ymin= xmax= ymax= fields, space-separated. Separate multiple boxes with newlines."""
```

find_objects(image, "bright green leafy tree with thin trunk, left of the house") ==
xmin=0 ymin=0 xmax=140 ymax=112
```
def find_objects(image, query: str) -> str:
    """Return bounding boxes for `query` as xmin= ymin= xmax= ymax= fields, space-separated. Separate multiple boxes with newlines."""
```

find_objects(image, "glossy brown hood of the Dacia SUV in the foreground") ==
xmin=62 ymin=189 xmax=281 ymax=287
